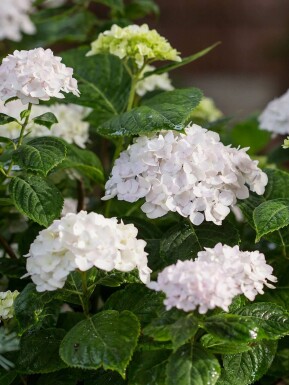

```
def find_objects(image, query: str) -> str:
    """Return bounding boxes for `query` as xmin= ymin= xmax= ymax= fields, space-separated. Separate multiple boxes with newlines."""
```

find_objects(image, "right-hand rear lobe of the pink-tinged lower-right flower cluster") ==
xmin=197 ymin=243 xmax=277 ymax=301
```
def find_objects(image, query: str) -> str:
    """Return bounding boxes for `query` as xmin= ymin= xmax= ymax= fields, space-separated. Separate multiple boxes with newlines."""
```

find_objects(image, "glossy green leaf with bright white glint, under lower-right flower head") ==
xmin=204 ymin=314 xmax=264 ymax=342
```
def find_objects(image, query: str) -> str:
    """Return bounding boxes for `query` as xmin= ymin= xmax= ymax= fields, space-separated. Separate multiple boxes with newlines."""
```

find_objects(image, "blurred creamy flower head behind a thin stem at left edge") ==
xmin=0 ymin=100 xmax=91 ymax=148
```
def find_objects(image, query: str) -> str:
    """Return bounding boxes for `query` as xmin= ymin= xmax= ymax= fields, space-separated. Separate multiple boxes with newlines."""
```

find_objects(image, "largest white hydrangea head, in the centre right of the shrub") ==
xmin=102 ymin=124 xmax=268 ymax=225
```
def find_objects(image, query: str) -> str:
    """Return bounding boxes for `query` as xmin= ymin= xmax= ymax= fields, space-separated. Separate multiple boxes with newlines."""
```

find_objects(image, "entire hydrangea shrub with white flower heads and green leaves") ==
xmin=0 ymin=0 xmax=289 ymax=385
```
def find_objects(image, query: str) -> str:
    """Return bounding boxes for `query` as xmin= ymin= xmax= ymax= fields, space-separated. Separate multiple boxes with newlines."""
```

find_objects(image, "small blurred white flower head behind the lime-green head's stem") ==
xmin=136 ymin=65 xmax=174 ymax=96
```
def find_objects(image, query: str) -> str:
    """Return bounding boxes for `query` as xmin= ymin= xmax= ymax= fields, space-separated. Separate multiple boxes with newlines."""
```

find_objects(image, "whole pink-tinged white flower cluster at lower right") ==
xmin=148 ymin=243 xmax=277 ymax=314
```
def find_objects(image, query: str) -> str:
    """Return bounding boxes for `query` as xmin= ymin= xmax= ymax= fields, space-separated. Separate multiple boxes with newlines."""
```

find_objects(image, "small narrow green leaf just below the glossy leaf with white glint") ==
xmin=201 ymin=334 xmax=251 ymax=354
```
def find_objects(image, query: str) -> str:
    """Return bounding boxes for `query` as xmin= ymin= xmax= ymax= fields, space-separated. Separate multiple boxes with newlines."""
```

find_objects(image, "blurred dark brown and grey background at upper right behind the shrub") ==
xmin=146 ymin=0 xmax=289 ymax=117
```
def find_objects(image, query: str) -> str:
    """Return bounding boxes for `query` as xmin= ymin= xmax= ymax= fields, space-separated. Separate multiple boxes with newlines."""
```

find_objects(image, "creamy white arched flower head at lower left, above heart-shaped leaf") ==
xmin=26 ymin=211 xmax=151 ymax=292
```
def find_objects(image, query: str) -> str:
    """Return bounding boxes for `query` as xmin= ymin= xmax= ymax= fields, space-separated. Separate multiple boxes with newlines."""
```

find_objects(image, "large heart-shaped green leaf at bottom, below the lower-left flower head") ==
xmin=60 ymin=311 xmax=140 ymax=377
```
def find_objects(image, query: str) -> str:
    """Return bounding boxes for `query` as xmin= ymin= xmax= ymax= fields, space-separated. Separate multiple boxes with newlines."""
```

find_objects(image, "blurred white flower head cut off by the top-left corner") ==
xmin=0 ymin=0 xmax=36 ymax=41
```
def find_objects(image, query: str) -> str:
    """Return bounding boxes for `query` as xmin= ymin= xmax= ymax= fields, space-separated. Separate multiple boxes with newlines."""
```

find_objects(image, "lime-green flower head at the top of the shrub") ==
xmin=87 ymin=24 xmax=181 ymax=68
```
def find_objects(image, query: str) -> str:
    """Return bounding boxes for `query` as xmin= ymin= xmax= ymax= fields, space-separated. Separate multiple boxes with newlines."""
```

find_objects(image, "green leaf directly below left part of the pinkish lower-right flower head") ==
xmin=143 ymin=310 xmax=198 ymax=350
